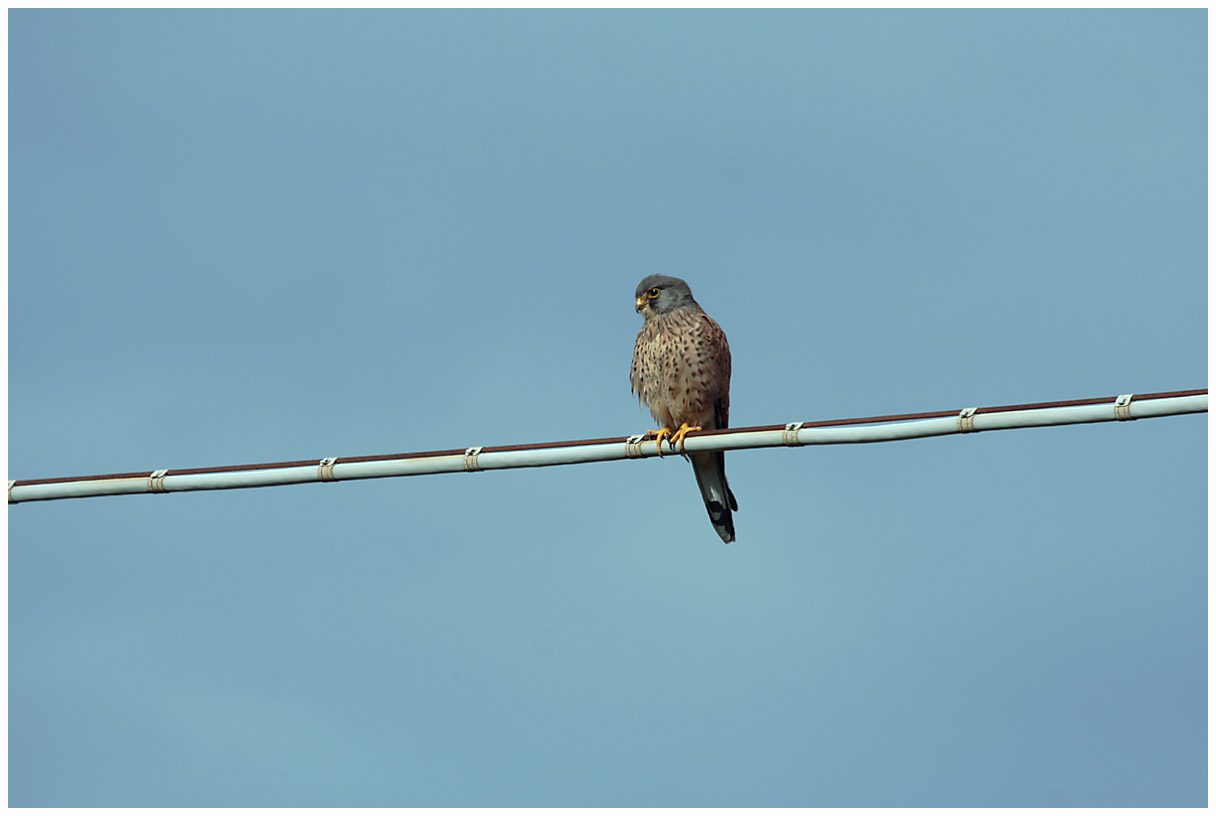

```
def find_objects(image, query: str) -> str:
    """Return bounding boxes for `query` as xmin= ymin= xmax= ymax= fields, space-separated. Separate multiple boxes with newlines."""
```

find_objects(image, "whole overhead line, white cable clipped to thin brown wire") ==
xmin=9 ymin=388 xmax=1207 ymax=505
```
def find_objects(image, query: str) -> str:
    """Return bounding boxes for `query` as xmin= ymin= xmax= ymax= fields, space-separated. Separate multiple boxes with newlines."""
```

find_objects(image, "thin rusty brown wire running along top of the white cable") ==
xmin=13 ymin=388 xmax=1207 ymax=486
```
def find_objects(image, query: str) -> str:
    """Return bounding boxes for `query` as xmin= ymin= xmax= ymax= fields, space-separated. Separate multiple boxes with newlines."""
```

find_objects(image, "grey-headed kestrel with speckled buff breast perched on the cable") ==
xmin=629 ymin=275 xmax=739 ymax=544
